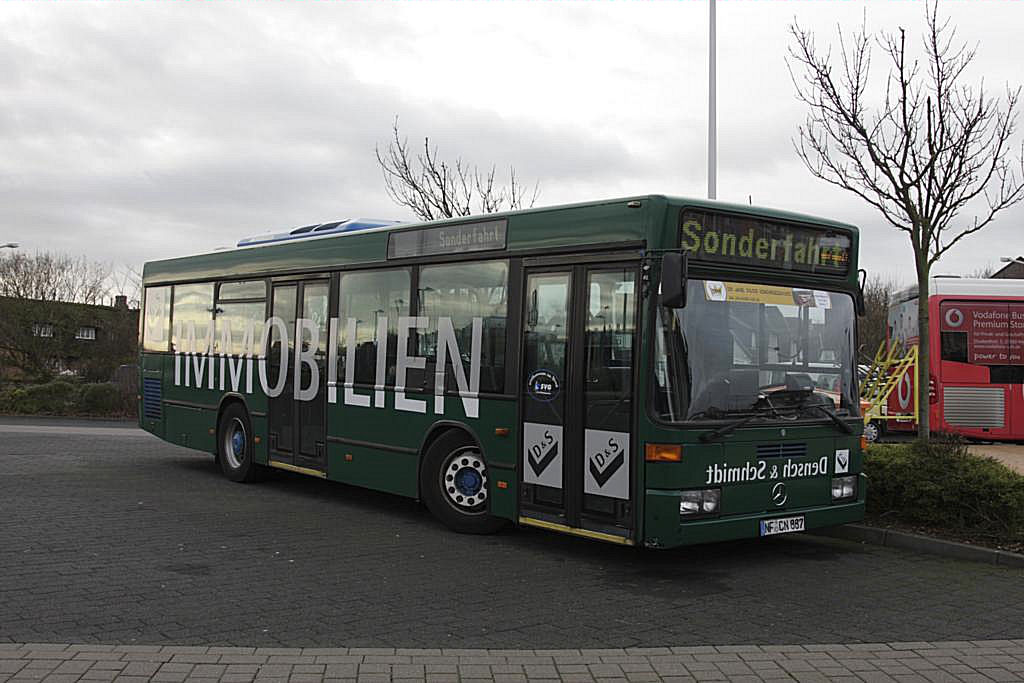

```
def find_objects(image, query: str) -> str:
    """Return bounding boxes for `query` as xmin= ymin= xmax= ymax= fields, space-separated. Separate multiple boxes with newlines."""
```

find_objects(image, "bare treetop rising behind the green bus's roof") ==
xmin=376 ymin=117 xmax=540 ymax=220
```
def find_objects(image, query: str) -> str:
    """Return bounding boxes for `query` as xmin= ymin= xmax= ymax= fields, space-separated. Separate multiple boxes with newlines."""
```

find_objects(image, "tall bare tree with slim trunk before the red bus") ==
xmin=788 ymin=3 xmax=1024 ymax=439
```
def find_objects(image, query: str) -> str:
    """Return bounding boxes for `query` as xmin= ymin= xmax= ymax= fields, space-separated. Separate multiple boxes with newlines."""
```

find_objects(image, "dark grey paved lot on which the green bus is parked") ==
xmin=0 ymin=419 xmax=1024 ymax=651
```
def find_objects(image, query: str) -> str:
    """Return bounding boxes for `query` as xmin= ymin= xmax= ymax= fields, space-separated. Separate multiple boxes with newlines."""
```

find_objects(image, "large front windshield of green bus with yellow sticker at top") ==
xmin=654 ymin=280 xmax=859 ymax=422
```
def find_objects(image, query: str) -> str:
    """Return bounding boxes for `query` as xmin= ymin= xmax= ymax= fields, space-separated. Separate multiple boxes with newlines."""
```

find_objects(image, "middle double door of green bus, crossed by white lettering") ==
xmin=269 ymin=280 xmax=331 ymax=473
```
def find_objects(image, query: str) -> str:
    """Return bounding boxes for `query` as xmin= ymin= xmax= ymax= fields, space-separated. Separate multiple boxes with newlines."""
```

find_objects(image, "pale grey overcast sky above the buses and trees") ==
xmin=0 ymin=0 xmax=1024 ymax=282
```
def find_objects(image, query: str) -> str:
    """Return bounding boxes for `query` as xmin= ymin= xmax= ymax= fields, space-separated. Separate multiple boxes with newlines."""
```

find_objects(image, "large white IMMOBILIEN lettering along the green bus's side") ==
xmin=174 ymin=315 xmax=483 ymax=418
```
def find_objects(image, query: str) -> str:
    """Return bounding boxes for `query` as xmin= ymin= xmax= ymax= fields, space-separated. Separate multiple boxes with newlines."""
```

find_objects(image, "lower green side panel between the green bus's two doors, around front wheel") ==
xmin=327 ymin=389 xmax=517 ymax=519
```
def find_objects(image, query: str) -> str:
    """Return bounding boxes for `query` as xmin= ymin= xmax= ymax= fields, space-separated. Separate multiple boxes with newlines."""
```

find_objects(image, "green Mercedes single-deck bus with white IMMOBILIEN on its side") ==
xmin=138 ymin=195 xmax=866 ymax=548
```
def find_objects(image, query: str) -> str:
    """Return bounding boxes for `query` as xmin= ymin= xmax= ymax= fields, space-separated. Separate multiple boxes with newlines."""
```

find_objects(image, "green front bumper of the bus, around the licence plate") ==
xmin=643 ymin=486 xmax=866 ymax=548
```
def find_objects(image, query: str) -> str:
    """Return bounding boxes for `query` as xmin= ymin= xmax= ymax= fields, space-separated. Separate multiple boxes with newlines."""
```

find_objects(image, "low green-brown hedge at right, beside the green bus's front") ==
xmin=864 ymin=439 xmax=1024 ymax=540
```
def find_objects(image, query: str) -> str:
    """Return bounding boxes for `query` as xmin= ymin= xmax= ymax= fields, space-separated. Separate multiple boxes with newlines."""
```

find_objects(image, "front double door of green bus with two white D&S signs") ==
xmin=519 ymin=264 xmax=639 ymax=544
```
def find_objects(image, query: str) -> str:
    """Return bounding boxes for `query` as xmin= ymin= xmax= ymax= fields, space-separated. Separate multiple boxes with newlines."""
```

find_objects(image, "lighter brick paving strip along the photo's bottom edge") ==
xmin=0 ymin=640 xmax=1024 ymax=683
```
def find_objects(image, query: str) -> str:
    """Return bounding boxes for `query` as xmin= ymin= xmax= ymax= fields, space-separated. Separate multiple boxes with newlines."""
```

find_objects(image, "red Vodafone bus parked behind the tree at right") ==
xmin=886 ymin=278 xmax=1024 ymax=441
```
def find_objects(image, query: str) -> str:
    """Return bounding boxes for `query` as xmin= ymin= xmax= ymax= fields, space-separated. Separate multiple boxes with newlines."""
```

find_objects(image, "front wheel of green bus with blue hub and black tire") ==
xmin=420 ymin=429 xmax=505 ymax=533
